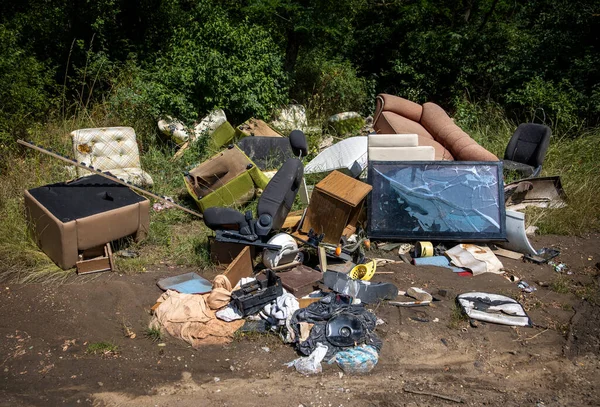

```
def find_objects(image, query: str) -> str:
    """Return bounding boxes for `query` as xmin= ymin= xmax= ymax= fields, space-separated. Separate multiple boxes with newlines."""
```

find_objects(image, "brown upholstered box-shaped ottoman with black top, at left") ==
xmin=25 ymin=175 xmax=150 ymax=270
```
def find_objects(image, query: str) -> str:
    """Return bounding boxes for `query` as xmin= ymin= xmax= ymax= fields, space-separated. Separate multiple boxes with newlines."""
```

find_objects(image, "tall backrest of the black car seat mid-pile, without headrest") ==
xmin=257 ymin=158 xmax=304 ymax=230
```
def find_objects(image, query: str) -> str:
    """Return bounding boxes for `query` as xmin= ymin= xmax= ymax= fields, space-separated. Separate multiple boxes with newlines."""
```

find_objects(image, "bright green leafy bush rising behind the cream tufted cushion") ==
xmin=112 ymin=3 xmax=287 ymax=126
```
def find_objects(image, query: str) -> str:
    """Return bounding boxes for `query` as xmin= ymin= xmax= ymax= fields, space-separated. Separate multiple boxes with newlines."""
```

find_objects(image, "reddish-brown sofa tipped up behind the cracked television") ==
xmin=373 ymin=93 xmax=498 ymax=161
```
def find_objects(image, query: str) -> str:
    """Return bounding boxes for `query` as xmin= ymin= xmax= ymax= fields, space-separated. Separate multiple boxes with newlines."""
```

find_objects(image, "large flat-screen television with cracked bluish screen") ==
xmin=368 ymin=161 xmax=506 ymax=241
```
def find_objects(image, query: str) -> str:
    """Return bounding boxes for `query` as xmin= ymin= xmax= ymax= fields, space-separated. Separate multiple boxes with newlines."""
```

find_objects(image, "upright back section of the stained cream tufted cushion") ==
xmin=71 ymin=127 xmax=140 ymax=176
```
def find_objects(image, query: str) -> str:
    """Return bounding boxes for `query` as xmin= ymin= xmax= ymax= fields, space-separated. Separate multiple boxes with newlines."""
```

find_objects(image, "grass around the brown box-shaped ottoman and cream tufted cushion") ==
xmin=0 ymin=104 xmax=216 ymax=283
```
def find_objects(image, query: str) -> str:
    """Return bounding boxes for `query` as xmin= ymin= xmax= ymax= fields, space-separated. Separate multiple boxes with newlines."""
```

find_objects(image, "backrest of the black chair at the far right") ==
xmin=504 ymin=123 xmax=552 ymax=168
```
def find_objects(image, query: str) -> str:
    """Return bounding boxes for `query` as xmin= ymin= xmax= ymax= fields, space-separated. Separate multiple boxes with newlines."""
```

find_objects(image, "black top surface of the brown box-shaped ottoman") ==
xmin=29 ymin=174 xmax=146 ymax=222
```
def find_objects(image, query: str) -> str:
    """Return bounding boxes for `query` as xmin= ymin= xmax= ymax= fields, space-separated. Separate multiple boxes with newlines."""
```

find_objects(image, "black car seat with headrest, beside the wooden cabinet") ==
xmin=204 ymin=130 xmax=308 ymax=250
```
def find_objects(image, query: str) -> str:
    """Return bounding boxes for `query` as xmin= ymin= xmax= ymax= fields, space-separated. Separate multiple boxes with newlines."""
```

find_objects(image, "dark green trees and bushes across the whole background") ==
xmin=0 ymin=0 xmax=600 ymax=139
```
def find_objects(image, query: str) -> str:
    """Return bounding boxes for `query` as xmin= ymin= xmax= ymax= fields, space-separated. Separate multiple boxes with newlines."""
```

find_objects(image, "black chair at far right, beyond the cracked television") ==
xmin=502 ymin=123 xmax=552 ymax=178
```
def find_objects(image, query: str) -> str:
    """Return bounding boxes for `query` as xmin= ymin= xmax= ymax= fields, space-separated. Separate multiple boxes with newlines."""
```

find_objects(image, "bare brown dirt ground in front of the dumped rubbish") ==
xmin=0 ymin=235 xmax=600 ymax=407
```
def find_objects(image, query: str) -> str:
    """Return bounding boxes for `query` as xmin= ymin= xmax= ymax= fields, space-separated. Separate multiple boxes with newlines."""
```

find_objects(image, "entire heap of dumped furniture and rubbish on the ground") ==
xmin=17 ymin=94 xmax=565 ymax=374
